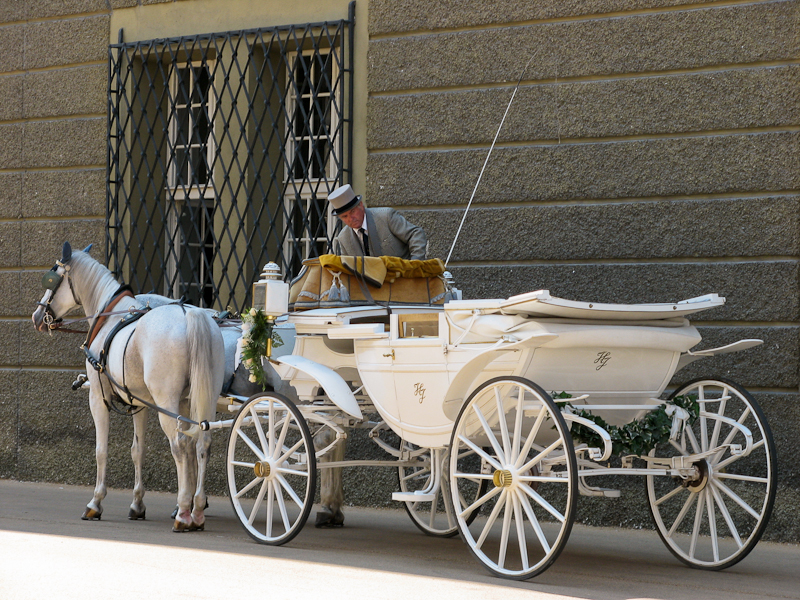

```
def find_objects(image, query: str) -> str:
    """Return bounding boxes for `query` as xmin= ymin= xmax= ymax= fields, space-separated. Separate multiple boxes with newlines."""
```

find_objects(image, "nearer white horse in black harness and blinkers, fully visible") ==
xmin=32 ymin=243 xmax=225 ymax=531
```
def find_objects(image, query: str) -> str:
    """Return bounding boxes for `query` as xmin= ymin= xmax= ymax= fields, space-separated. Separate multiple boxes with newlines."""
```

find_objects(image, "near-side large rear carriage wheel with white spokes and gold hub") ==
xmin=449 ymin=377 xmax=578 ymax=579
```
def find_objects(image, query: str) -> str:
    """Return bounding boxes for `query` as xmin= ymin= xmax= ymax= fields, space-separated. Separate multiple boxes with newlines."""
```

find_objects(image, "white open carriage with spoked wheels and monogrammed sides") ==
xmin=217 ymin=290 xmax=776 ymax=579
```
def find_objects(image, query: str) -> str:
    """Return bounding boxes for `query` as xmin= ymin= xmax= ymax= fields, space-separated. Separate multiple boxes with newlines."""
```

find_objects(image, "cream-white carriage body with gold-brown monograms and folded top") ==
xmin=280 ymin=292 xmax=712 ymax=448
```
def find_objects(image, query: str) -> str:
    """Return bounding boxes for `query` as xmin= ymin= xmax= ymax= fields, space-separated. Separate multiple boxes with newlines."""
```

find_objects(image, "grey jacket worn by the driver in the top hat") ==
xmin=333 ymin=208 xmax=428 ymax=260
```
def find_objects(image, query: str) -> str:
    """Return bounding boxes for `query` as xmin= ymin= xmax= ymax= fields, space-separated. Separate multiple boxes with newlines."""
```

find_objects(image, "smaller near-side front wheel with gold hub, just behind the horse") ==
xmin=227 ymin=392 xmax=317 ymax=546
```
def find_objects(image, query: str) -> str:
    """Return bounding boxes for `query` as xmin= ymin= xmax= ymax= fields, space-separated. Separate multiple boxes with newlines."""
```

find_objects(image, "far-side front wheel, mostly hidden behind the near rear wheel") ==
xmin=398 ymin=449 xmax=489 ymax=537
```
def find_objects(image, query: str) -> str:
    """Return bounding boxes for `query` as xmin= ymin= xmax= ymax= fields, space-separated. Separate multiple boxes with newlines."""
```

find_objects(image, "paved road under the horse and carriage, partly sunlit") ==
xmin=0 ymin=480 xmax=800 ymax=600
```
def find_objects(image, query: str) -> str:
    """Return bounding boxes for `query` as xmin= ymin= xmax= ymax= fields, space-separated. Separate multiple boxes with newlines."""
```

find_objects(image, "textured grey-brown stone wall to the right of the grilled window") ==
xmin=365 ymin=0 xmax=800 ymax=541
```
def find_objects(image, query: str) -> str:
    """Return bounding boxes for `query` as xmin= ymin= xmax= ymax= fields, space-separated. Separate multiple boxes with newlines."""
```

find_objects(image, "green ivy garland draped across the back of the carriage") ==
xmin=552 ymin=392 xmax=700 ymax=456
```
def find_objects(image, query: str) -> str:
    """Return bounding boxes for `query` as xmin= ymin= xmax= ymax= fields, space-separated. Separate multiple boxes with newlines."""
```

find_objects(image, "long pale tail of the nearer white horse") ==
xmin=186 ymin=309 xmax=225 ymax=422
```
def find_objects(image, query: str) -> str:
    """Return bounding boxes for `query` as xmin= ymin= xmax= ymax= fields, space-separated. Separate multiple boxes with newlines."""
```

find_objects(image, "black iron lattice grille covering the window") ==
xmin=106 ymin=8 xmax=355 ymax=311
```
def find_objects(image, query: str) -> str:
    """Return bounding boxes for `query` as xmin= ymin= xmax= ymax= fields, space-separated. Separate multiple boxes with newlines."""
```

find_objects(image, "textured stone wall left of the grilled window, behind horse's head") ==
xmin=0 ymin=0 xmax=195 ymax=494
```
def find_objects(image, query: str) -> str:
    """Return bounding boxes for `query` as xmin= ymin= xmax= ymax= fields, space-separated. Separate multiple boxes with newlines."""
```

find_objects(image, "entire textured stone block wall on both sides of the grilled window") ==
xmin=0 ymin=0 xmax=800 ymax=542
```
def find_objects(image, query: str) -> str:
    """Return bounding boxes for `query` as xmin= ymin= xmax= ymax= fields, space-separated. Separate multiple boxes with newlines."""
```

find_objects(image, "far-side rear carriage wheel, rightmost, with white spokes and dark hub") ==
xmin=646 ymin=379 xmax=777 ymax=571
